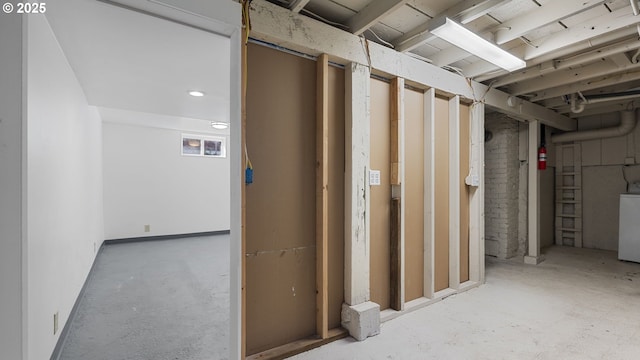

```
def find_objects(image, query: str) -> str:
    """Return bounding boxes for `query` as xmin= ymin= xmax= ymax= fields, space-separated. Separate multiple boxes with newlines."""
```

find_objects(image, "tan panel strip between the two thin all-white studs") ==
xmin=436 ymin=97 xmax=449 ymax=291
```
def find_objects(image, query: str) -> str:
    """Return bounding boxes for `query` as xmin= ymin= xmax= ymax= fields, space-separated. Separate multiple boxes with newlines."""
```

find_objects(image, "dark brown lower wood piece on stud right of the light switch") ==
xmin=390 ymin=198 xmax=403 ymax=311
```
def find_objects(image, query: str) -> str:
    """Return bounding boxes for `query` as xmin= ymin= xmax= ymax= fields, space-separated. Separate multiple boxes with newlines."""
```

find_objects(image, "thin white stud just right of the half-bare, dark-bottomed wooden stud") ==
xmin=424 ymin=89 xmax=436 ymax=299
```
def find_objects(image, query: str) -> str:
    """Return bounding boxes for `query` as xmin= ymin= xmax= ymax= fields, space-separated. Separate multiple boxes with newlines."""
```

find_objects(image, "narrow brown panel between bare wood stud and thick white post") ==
xmin=329 ymin=66 xmax=344 ymax=329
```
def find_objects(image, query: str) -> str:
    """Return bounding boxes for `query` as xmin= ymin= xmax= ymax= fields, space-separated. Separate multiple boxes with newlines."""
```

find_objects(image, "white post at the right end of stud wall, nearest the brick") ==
xmin=466 ymin=102 xmax=484 ymax=283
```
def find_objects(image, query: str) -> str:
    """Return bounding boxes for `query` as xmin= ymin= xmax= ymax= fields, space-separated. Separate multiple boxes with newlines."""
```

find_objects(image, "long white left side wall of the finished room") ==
xmin=27 ymin=14 xmax=104 ymax=360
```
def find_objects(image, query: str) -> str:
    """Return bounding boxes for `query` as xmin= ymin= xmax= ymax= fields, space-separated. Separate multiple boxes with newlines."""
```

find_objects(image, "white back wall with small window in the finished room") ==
xmin=101 ymin=119 xmax=230 ymax=239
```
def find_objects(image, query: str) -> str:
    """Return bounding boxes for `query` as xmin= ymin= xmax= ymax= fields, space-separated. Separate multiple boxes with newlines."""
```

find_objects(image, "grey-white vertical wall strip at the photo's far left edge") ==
xmin=0 ymin=14 xmax=27 ymax=360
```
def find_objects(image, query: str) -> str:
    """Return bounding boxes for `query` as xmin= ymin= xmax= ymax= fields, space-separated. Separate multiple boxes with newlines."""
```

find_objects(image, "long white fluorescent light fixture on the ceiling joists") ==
xmin=429 ymin=17 xmax=527 ymax=71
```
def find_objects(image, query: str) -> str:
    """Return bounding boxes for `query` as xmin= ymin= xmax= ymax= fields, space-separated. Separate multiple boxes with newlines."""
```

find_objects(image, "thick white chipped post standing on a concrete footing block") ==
xmin=342 ymin=63 xmax=380 ymax=340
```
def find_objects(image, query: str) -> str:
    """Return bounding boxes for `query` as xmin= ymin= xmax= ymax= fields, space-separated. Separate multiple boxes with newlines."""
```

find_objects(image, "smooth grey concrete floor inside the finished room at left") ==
xmin=60 ymin=235 xmax=229 ymax=360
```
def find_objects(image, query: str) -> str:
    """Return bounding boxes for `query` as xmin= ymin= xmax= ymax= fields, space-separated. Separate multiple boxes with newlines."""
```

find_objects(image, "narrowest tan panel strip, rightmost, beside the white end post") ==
xmin=460 ymin=105 xmax=471 ymax=283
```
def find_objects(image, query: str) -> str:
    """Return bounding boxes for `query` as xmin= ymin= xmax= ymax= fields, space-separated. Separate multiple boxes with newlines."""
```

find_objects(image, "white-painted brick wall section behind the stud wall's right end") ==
xmin=484 ymin=113 xmax=520 ymax=259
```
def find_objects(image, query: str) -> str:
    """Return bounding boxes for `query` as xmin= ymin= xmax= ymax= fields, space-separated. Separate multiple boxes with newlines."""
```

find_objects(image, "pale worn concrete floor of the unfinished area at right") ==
xmin=294 ymin=247 xmax=640 ymax=360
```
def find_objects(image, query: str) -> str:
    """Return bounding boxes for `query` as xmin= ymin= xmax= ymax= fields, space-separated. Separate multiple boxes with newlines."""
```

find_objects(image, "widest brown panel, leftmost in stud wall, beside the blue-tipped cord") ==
xmin=246 ymin=44 xmax=316 ymax=354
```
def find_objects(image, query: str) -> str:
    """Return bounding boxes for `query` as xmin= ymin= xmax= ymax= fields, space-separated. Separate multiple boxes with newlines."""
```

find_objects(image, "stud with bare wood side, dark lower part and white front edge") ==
xmin=389 ymin=78 xmax=404 ymax=311
